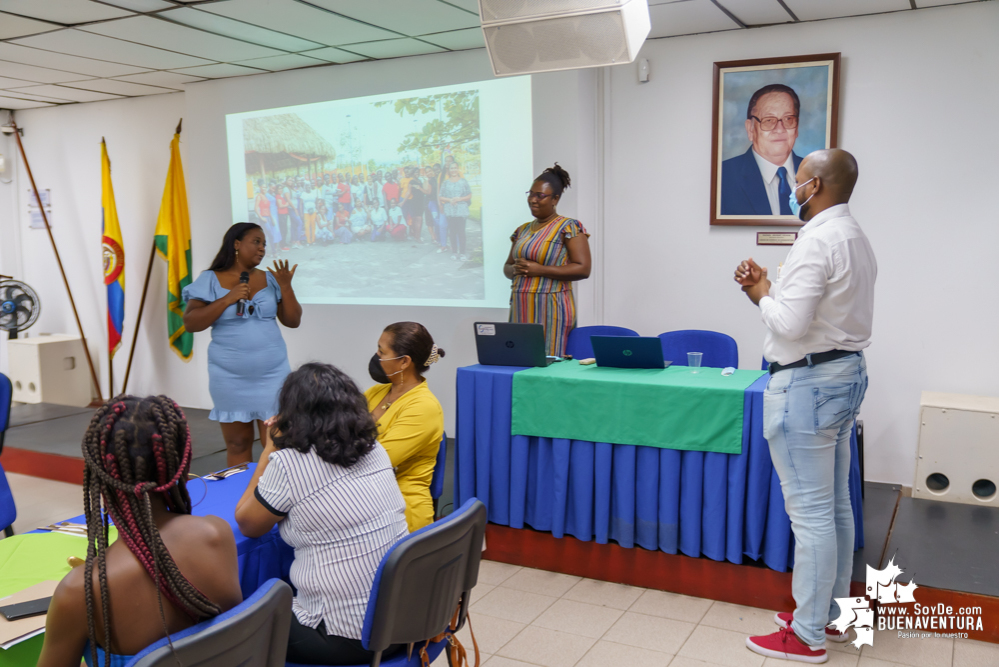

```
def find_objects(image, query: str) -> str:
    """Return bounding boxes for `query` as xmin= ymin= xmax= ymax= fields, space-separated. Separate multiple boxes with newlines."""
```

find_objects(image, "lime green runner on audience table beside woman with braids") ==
xmin=0 ymin=528 xmax=118 ymax=667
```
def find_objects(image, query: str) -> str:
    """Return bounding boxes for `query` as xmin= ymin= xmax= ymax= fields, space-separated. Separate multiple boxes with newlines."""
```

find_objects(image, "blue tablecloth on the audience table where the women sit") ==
xmin=47 ymin=463 xmax=295 ymax=599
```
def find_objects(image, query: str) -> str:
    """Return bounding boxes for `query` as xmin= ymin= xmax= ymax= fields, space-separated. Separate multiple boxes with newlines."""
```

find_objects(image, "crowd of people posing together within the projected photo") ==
xmin=249 ymin=153 xmax=473 ymax=261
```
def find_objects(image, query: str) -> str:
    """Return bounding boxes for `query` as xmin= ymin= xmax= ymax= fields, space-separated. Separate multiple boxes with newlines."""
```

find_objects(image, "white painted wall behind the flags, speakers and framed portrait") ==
xmin=7 ymin=3 xmax=999 ymax=484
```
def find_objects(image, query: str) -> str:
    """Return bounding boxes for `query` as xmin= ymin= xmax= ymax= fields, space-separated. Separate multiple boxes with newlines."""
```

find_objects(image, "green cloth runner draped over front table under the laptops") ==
xmin=510 ymin=361 xmax=764 ymax=454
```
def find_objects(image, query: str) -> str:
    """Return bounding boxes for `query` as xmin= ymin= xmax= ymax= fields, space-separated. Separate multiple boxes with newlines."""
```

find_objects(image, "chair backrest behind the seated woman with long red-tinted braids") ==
xmin=126 ymin=579 xmax=292 ymax=667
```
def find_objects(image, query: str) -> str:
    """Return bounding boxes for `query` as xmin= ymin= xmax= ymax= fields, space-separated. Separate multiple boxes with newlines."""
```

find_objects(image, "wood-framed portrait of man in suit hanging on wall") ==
xmin=711 ymin=53 xmax=839 ymax=226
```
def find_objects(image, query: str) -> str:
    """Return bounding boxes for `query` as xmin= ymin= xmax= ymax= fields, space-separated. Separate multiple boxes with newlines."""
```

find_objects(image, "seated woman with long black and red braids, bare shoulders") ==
xmin=38 ymin=396 xmax=243 ymax=667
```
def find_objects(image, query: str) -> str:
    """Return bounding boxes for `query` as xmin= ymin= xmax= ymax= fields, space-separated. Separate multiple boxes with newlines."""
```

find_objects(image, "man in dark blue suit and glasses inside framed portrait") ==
xmin=721 ymin=83 xmax=801 ymax=215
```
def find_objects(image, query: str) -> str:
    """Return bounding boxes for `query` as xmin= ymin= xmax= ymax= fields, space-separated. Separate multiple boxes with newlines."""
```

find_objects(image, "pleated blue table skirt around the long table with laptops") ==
xmin=454 ymin=365 xmax=864 ymax=572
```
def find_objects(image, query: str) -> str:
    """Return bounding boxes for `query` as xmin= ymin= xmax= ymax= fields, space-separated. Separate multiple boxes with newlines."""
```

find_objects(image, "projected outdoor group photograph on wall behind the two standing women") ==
xmin=227 ymin=77 xmax=531 ymax=305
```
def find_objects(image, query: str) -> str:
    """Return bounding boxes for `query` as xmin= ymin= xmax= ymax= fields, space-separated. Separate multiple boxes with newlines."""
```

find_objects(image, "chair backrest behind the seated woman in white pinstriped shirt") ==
xmin=361 ymin=498 xmax=486 ymax=653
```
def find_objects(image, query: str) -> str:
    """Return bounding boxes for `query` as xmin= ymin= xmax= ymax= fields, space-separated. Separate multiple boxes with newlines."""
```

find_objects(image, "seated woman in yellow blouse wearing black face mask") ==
xmin=364 ymin=322 xmax=444 ymax=532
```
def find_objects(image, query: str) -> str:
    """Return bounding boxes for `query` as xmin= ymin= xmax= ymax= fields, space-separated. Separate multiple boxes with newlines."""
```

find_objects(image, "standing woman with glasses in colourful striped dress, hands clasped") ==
xmin=503 ymin=162 xmax=590 ymax=357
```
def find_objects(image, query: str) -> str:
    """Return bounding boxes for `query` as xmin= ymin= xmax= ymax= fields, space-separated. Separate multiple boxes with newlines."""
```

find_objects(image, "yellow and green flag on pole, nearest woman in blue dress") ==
xmin=156 ymin=126 xmax=194 ymax=361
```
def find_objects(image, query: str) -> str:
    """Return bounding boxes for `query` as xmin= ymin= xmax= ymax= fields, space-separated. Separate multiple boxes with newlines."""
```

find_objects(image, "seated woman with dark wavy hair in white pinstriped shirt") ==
xmin=236 ymin=363 xmax=408 ymax=665
